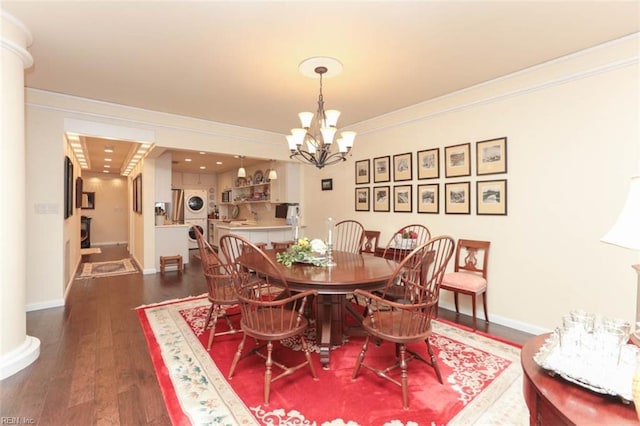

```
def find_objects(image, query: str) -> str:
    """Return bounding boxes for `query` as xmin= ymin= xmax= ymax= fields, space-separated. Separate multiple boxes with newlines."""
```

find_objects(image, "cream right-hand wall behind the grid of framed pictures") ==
xmin=303 ymin=35 xmax=640 ymax=332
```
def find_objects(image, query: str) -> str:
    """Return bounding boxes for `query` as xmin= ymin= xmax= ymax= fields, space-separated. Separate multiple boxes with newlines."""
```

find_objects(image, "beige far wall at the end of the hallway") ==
xmin=81 ymin=173 xmax=132 ymax=246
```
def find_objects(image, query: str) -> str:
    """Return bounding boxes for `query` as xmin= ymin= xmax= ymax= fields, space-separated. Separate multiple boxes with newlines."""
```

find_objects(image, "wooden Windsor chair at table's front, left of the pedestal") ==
xmin=220 ymin=234 xmax=318 ymax=405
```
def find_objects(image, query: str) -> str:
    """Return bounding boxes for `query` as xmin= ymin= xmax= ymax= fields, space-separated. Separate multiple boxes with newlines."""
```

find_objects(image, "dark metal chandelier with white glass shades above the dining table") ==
xmin=287 ymin=57 xmax=356 ymax=169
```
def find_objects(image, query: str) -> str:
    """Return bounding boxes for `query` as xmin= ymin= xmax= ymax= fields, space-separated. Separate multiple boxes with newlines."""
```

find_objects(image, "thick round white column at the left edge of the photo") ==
xmin=0 ymin=10 xmax=40 ymax=379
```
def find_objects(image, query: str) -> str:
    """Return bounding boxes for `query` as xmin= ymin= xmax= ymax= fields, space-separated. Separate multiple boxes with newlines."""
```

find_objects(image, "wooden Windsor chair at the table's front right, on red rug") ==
xmin=352 ymin=236 xmax=455 ymax=410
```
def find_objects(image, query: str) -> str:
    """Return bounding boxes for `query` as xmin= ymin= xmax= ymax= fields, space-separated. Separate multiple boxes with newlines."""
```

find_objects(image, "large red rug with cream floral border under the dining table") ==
xmin=137 ymin=296 xmax=529 ymax=426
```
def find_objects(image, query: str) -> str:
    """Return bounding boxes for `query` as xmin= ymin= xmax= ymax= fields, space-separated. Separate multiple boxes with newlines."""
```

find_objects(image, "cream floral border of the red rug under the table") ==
xmin=136 ymin=295 xmax=529 ymax=426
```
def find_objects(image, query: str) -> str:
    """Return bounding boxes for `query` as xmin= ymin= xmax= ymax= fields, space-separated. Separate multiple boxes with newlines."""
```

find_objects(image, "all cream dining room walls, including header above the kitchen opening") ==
xmin=22 ymin=37 xmax=640 ymax=332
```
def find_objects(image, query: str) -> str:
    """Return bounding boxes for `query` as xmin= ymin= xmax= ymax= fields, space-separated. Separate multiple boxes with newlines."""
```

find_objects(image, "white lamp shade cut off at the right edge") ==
xmin=601 ymin=176 xmax=640 ymax=250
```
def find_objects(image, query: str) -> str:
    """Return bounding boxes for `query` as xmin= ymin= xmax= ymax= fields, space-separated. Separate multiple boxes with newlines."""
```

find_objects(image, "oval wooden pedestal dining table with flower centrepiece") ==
xmin=238 ymin=250 xmax=397 ymax=369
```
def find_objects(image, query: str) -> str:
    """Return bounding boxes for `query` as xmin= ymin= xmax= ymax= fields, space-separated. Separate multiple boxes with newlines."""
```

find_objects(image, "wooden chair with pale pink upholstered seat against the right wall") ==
xmin=441 ymin=239 xmax=491 ymax=330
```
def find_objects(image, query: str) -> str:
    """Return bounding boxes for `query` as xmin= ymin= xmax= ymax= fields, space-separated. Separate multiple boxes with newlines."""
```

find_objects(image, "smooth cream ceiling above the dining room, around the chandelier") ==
xmin=2 ymin=0 xmax=640 ymax=173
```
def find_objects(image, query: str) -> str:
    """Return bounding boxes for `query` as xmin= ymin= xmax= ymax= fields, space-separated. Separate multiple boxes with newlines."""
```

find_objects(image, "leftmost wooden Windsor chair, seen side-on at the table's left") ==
xmin=193 ymin=226 xmax=240 ymax=351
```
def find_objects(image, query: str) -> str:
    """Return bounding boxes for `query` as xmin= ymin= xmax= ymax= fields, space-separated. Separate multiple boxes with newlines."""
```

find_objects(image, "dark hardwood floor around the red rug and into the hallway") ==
xmin=0 ymin=246 xmax=531 ymax=426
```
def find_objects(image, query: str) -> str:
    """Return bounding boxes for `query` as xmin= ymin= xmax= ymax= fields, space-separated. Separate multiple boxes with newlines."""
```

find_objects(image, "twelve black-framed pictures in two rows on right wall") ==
xmin=355 ymin=137 xmax=507 ymax=215
